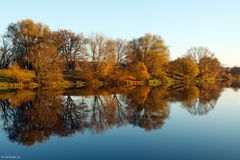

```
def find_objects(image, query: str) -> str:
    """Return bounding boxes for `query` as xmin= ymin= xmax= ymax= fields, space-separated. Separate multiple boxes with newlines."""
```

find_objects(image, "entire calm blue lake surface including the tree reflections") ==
xmin=0 ymin=84 xmax=240 ymax=160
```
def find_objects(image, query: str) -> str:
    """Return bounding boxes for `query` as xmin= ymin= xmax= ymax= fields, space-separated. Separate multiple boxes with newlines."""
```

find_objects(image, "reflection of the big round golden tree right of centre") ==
xmin=128 ymin=87 xmax=169 ymax=130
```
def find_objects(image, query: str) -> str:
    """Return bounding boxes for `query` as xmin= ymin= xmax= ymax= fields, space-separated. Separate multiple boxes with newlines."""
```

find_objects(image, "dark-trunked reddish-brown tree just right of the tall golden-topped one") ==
xmin=56 ymin=30 xmax=87 ymax=71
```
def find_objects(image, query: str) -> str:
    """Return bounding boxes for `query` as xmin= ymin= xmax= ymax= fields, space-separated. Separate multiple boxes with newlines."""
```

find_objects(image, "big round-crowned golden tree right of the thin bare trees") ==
xmin=128 ymin=34 xmax=169 ymax=77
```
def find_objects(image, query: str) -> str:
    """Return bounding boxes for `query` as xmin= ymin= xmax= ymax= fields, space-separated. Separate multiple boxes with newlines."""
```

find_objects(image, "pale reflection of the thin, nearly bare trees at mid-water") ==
xmin=90 ymin=93 xmax=127 ymax=133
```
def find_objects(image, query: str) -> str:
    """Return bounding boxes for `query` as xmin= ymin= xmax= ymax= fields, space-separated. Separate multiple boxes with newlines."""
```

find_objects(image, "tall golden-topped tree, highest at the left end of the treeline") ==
xmin=6 ymin=19 xmax=49 ymax=68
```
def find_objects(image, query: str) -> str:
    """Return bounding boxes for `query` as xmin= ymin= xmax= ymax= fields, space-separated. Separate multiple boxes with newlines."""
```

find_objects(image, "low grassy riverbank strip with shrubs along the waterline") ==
xmin=0 ymin=67 xmax=237 ymax=90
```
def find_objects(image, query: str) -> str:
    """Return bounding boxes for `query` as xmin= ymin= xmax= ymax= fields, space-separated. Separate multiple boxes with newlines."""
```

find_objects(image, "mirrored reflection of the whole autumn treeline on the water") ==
xmin=0 ymin=84 xmax=233 ymax=146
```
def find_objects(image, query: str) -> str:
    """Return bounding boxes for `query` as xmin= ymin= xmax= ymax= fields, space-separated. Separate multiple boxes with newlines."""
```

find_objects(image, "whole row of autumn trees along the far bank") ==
xmin=0 ymin=19 xmax=237 ymax=84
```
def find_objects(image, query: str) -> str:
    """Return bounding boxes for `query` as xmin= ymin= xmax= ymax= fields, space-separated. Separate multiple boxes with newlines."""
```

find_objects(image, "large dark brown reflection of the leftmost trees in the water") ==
xmin=0 ymin=91 xmax=61 ymax=146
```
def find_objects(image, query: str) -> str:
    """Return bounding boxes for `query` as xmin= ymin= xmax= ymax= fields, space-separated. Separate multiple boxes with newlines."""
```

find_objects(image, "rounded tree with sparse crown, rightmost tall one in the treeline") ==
xmin=186 ymin=47 xmax=222 ymax=80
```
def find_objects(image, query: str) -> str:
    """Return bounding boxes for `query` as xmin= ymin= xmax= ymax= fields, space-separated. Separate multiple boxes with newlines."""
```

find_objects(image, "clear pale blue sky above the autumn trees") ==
xmin=0 ymin=0 xmax=240 ymax=66
